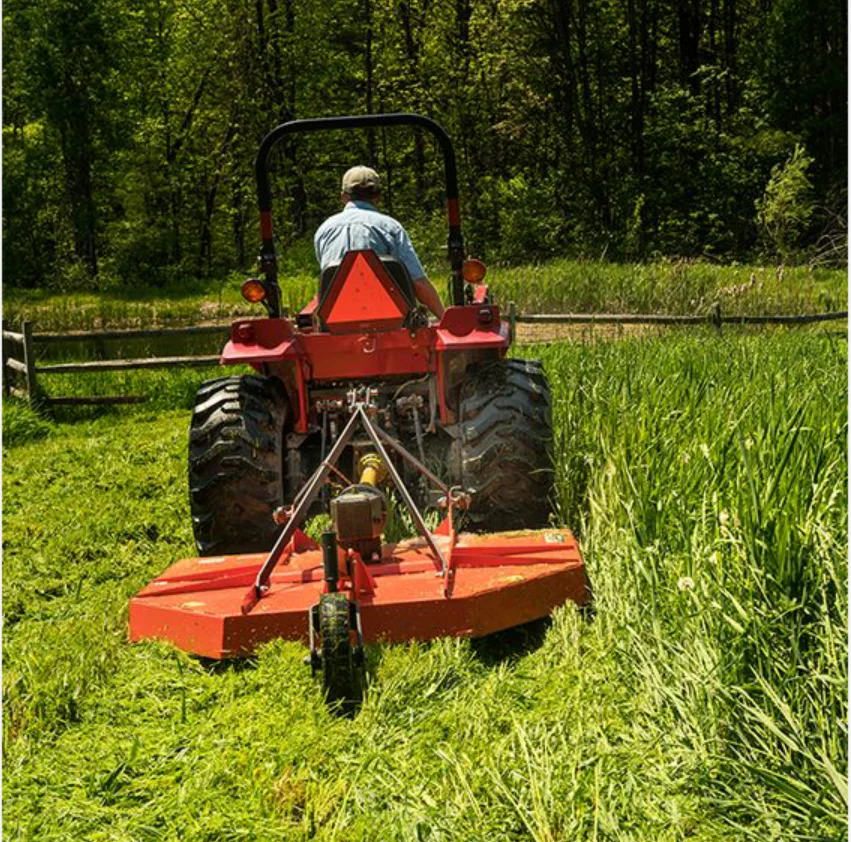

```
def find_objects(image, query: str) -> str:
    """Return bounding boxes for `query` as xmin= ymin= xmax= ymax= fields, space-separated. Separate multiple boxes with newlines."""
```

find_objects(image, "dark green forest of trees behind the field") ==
xmin=3 ymin=0 xmax=847 ymax=289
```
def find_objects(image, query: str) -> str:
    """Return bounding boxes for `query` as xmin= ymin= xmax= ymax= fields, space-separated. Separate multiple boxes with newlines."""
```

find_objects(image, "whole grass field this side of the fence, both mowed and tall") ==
xmin=3 ymin=331 xmax=847 ymax=842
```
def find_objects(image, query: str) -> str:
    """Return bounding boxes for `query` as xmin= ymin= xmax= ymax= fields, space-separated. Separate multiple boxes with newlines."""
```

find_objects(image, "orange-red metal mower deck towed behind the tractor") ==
xmin=130 ymin=529 xmax=588 ymax=658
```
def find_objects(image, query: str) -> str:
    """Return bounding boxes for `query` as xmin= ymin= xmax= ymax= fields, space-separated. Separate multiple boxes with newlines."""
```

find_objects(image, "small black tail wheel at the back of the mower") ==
xmin=317 ymin=593 xmax=364 ymax=705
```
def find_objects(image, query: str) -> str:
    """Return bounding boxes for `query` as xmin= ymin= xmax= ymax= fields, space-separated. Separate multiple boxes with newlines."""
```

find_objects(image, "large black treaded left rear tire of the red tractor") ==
xmin=189 ymin=375 xmax=291 ymax=556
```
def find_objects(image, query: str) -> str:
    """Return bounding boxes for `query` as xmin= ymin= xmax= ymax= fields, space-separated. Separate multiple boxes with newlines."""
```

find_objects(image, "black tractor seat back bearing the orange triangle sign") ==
xmin=316 ymin=249 xmax=417 ymax=333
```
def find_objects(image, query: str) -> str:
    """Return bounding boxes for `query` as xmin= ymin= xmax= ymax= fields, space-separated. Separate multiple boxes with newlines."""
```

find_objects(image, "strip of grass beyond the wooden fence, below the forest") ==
xmin=3 ymin=260 xmax=848 ymax=331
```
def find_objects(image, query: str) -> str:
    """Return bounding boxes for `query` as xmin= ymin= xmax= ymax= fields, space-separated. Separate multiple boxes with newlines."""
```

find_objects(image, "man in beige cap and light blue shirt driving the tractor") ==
xmin=313 ymin=167 xmax=444 ymax=318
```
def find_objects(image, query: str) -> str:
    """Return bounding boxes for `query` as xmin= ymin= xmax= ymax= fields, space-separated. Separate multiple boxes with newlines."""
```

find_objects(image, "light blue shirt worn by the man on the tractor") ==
xmin=313 ymin=201 xmax=426 ymax=281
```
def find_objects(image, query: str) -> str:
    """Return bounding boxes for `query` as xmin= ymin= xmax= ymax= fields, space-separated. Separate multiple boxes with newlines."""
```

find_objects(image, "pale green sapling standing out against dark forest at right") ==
xmin=756 ymin=145 xmax=815 ymax=260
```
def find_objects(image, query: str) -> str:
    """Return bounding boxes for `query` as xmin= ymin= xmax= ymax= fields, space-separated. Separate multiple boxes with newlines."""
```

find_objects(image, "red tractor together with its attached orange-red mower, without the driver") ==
xmin=130 ymin=114 xmax=588 ymax=699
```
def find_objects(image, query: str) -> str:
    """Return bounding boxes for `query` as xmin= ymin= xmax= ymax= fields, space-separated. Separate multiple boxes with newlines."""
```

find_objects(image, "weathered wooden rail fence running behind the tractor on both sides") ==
xmin=3 ymin=303 xmax=848 ymax=406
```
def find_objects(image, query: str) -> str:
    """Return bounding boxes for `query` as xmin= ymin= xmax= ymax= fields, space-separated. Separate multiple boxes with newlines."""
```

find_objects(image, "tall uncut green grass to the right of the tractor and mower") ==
xmin=544 ymin=334 xmax=847 ymax=838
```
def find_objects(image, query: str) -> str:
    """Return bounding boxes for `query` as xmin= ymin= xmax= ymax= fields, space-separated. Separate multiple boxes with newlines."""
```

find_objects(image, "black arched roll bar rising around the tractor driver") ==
xmin=254 ymin=108 xmax=464 ymax=316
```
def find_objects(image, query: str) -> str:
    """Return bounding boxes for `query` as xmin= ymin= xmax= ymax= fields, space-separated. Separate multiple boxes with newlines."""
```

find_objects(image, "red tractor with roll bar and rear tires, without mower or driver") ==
xmin=189 ymin=114 xmax=553 ymax=555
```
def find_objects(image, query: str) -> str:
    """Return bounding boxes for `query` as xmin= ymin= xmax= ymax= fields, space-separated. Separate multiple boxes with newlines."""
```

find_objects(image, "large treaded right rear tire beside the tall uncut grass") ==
xmin=450 ymin=360 xmax=554 ymax=532
